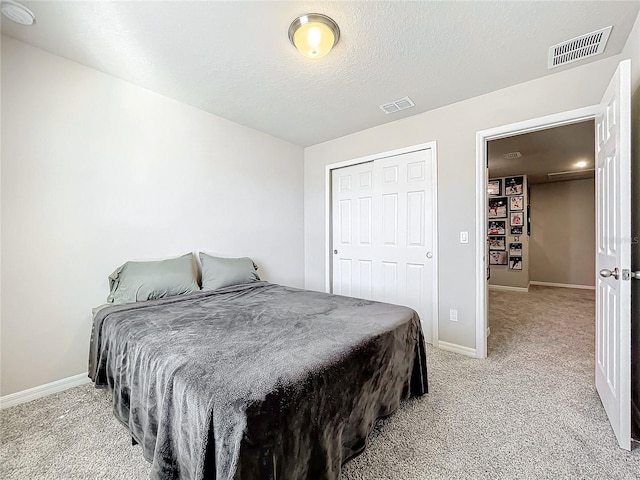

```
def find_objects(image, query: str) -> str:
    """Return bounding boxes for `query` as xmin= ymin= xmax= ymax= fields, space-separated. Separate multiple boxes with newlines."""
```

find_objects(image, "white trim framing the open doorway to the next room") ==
xmin=476 ymin=105 xmax=600 ymax=358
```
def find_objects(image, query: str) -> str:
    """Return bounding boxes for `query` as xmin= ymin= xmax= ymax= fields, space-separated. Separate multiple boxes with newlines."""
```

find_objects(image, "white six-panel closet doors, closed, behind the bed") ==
xmin=331 ymin=149 xmax=437 ymax=343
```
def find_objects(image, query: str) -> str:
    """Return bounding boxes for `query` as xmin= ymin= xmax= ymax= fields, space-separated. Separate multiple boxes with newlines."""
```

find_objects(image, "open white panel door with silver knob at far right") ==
xmin=596 ymin=60 xmax=631 ymax=450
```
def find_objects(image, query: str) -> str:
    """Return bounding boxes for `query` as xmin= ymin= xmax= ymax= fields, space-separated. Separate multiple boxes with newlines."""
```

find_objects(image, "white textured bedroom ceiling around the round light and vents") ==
xmin=1 ymin=1 xmax=640 ymax=146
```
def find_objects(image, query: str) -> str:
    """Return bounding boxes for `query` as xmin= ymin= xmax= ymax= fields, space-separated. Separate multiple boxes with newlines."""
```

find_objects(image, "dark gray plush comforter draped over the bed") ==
xmin=89 ymin=282 xmax=427 ymax=480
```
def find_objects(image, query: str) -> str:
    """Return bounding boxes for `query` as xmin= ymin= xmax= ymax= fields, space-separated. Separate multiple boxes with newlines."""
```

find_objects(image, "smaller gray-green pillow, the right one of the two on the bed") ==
xmin=200 ymin=252 xmax=260 ymax=290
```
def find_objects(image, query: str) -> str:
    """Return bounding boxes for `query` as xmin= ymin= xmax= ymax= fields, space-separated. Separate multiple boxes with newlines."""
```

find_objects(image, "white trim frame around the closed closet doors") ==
xmin=324 ymin=140 xmax=439 ymax=346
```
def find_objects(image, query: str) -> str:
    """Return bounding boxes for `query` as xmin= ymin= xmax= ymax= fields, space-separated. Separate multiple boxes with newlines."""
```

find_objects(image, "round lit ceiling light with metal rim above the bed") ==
xmin=289 ymin=13 xmax=340 ymax=58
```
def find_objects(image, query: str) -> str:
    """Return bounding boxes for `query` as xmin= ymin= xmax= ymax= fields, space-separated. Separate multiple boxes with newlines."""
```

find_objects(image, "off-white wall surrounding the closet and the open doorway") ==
xmin=304 ymin=53 xmax=632 ymax=349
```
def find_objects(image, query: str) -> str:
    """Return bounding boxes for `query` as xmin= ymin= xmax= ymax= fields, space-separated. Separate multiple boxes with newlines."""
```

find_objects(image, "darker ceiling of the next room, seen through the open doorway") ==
xmin=488 ymin=120 xmax=595 ymax=184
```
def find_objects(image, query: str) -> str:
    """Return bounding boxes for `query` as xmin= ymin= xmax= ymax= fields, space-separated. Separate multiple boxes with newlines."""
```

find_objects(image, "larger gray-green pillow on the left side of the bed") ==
xmin=107 ymin=253 xmax=200 ymax=304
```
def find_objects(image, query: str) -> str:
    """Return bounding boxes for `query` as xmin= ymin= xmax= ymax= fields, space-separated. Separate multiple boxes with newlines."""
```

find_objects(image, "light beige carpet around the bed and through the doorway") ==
xmin=0 ymin=287 xmax=640 ymax=480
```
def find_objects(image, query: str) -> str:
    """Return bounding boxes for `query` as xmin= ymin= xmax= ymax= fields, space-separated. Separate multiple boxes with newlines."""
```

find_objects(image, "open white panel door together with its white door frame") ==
xmin=476 ymin=60 xmax=631 ymax=450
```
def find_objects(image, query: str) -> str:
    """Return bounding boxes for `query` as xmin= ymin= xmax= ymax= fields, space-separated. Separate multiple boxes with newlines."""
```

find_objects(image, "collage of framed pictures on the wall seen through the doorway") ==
xmin=487 ymin=175 xmax=526 ymax=271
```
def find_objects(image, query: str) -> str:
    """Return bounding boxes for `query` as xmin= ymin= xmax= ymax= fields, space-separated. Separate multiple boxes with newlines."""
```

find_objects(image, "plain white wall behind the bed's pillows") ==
xmin=1 ymin=37 xmax=303 ymax=395
